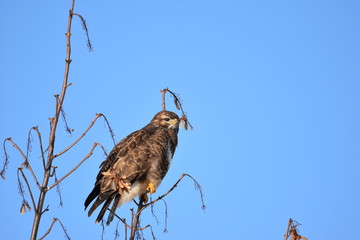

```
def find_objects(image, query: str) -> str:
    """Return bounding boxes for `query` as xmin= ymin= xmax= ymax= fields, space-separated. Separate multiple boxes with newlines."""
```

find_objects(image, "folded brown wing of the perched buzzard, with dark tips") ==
xmin=84 ymin=129 xmax=151 ymax=216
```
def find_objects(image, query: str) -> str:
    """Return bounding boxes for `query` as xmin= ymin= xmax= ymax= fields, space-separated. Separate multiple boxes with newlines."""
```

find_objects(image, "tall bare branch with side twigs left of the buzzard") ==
xmin=0 ymin=0 xmax=95 ymax=240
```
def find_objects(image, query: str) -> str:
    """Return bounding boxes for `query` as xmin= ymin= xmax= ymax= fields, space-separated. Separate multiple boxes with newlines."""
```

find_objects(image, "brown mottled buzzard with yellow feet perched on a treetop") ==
xmin=84 ymin=111 xmax=180 ymax=225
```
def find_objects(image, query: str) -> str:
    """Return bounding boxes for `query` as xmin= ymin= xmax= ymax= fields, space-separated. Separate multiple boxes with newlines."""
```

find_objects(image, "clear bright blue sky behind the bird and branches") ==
xmin=0 ymin=0 xmax=360 ymax=240
